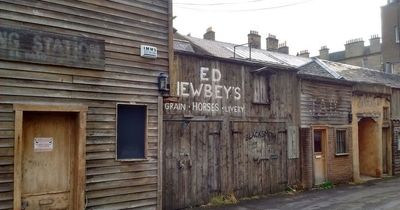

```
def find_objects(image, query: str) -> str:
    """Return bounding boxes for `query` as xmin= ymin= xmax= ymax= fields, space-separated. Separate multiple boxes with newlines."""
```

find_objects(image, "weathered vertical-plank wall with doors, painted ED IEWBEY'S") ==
xmin=163 ymin=53 xmax=301 ymax=209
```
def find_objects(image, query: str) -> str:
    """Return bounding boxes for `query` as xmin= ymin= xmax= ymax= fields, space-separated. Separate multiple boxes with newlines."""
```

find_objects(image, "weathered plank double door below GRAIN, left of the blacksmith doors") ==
xmin=163 ymin=121 xmax=221 ymax=209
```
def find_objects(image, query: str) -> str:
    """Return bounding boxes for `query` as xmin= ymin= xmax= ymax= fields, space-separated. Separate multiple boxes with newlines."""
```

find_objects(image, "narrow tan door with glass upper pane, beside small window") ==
xmin=313 ymin=129 xmax=327 ymax=185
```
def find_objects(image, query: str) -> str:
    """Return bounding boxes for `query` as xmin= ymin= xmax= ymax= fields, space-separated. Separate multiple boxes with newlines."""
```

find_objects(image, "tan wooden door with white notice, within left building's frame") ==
xmin=21 ymin=112 xmax=77 ymax=210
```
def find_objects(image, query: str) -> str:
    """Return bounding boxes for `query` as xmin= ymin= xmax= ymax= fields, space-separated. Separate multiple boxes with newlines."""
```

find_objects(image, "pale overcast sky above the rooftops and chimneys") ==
xmin=173 ymin=0 xmax=387 ymax=55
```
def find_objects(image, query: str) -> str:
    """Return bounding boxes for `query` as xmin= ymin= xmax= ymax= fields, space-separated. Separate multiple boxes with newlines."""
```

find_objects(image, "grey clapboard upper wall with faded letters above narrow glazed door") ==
xmin=300 ymin=80 xmax=352 ymax=127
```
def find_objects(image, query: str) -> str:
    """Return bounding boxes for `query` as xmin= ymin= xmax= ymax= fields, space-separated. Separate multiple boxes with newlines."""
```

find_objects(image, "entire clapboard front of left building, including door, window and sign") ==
xmin=0 ymin=0 xmax=172 ymax=210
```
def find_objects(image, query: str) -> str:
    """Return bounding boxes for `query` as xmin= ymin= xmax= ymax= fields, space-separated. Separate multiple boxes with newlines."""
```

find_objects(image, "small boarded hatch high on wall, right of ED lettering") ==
xmin=253 ymin=74 xmax=269 ymax=104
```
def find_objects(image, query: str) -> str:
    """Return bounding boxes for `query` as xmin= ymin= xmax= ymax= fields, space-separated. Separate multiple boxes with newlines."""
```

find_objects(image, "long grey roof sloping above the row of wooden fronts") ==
xmin=174 ymin=36 xmax=400 ymax=88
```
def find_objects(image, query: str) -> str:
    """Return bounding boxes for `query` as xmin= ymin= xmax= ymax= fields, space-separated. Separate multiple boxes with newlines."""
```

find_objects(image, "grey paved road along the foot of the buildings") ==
xmin=198 ymin=177 xmax=400 ymax=210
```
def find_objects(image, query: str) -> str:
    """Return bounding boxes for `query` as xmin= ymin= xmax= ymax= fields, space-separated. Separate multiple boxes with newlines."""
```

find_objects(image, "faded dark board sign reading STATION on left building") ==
xmin=0 ymin=27 xmax=105 ymax=69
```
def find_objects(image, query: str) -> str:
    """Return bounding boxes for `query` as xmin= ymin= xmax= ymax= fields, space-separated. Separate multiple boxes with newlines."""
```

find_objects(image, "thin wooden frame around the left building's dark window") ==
xmin=115 ymin=103 xmax=149 ymax=161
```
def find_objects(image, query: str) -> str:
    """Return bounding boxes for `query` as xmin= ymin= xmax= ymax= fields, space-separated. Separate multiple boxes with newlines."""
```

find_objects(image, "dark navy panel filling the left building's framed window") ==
xmin=117 ymin=104 xmax=147 ymax=160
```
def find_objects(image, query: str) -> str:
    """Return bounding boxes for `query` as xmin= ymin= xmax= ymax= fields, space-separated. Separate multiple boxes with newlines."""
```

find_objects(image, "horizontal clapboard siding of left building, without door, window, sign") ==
xmin=0 ymin=0 xmax=171 ymax=209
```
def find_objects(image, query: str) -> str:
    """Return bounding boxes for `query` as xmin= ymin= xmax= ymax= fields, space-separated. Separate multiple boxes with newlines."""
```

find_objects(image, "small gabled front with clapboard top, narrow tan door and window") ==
xmin=299 ymin=60 xmax=353 ymax=188
